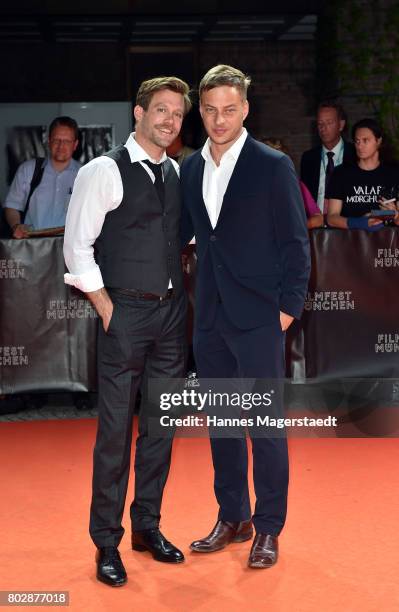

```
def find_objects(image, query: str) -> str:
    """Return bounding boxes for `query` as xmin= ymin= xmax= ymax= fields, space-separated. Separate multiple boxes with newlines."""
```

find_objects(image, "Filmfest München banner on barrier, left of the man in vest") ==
xmin=0 ymin=237 xmax=97 ymax=394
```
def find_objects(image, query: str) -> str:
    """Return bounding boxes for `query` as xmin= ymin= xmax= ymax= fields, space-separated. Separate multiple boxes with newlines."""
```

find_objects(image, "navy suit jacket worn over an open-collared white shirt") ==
xmin=181 ymin=135 xmax=310 ymax=329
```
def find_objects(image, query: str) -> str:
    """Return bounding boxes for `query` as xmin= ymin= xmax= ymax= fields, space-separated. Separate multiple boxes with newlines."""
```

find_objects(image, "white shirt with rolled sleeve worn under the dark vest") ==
xmin=64 ymin=133 xmax=179 ymax=292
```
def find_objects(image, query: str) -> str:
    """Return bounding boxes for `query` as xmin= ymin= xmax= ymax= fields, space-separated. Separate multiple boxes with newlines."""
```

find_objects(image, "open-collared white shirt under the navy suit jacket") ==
xmin=205 ymin=128 xmax=248 ymax=228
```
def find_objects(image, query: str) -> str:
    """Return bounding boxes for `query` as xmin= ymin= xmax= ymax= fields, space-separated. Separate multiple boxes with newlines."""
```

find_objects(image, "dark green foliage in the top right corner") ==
xmin=319 ymin=0 xmax=399 ymax=157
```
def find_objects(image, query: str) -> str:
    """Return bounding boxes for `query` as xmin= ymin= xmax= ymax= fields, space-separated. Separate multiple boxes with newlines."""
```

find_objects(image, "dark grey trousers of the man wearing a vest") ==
xmin=90 ymin=290 xmax=186 ymax=547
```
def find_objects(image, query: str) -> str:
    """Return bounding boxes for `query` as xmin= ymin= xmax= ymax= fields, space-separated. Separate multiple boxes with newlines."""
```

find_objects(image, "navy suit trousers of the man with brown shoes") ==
xmin=194 ymin=304 xmax=288 ymax=535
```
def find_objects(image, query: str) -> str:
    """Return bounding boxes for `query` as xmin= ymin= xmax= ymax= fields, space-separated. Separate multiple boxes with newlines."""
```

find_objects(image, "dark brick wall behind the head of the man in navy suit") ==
xmin=199 ymin=42 xmax=315 ymax=166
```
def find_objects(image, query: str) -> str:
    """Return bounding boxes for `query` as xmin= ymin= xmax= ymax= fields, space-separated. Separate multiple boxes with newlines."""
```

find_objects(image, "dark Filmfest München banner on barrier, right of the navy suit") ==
xmin=292 ymin=227 xmax=399 ymax=382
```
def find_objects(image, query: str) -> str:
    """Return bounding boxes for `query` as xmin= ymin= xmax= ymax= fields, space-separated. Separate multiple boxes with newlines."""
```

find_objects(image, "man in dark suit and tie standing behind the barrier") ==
xmin=301 ymin=101 xmax=356 ymax=214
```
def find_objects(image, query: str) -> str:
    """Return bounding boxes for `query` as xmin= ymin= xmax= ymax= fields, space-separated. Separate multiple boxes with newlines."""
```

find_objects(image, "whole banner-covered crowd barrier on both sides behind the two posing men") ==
xmin=0 ymin=227 xmax=399 ymax=394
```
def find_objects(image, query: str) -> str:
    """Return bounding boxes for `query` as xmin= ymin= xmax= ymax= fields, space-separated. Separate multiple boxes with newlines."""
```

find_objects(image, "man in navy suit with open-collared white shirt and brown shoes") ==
xmin=181 ymin=65 xmax=310 ymax=568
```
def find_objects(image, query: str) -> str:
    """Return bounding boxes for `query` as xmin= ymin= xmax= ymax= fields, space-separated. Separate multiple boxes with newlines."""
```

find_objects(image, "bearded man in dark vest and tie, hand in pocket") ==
xmin=64 ymin=77 xmax=190 ymax=586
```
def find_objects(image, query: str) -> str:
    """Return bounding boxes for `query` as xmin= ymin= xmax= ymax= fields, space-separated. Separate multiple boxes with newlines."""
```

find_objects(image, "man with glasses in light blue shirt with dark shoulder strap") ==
xmin=3 ymin=117 xmax=81 ymax=238
